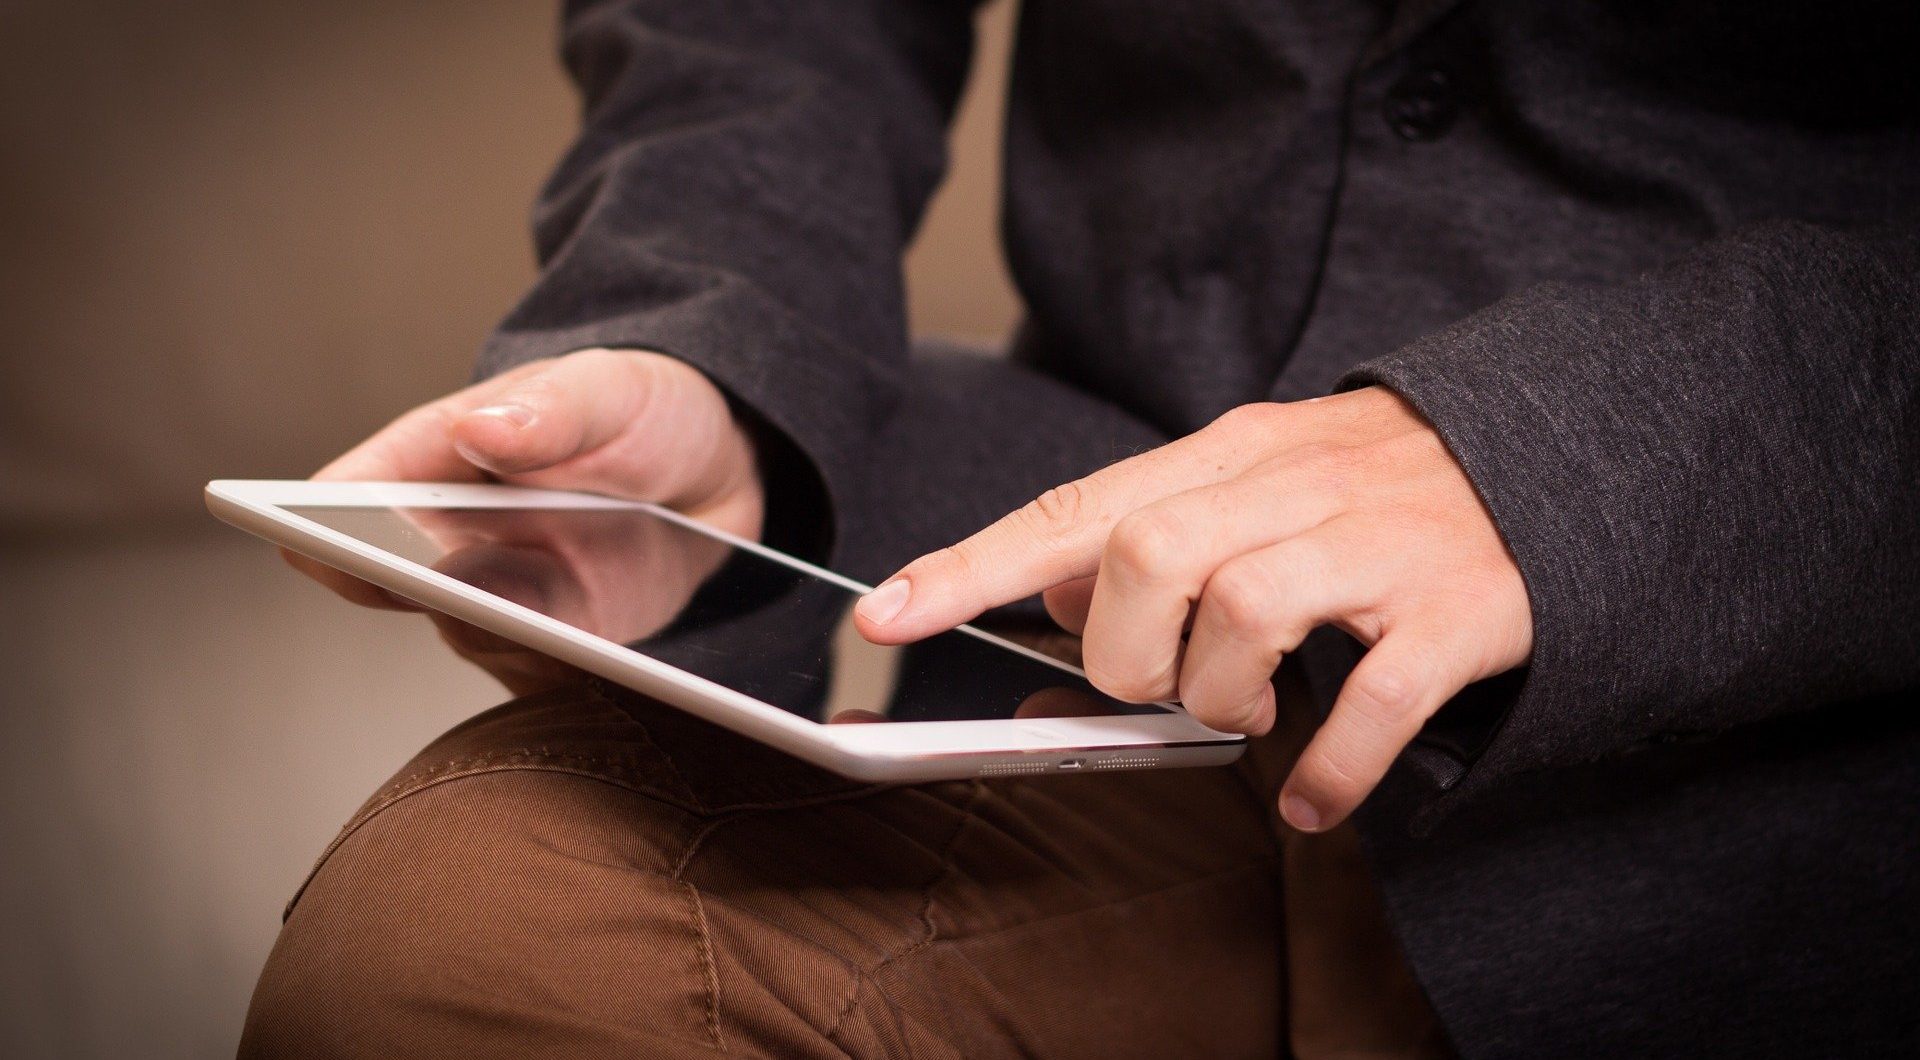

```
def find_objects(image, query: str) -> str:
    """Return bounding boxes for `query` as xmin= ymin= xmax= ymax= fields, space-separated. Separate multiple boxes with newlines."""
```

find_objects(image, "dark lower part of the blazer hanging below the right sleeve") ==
xmin=1363 ymin=683 xmax=1920 ymax=1058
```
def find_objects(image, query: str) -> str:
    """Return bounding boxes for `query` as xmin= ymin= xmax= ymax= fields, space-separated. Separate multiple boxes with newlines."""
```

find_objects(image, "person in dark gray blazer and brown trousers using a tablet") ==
xmin=242 ymin=0 xmax=1920 ymax=1056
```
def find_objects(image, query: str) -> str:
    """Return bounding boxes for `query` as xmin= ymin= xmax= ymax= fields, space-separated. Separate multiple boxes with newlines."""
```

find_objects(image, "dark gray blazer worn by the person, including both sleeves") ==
xmin=482 ymin=0 xmax=1920 ymax=1056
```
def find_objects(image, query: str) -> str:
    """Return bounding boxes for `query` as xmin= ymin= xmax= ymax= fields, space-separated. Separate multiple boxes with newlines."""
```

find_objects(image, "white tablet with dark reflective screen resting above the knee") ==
xmin=207 ymin=480 xmax=1246 ymax=782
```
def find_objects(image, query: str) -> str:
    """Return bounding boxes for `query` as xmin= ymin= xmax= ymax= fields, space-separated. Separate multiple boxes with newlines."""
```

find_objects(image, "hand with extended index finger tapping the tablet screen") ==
xmin=856 ymin=388 xmax=1532 ymax=831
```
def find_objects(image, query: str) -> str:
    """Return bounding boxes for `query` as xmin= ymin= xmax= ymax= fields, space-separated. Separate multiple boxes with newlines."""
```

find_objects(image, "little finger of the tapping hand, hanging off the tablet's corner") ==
xmin=1281 ymin=630 xmax=1476 ymax=831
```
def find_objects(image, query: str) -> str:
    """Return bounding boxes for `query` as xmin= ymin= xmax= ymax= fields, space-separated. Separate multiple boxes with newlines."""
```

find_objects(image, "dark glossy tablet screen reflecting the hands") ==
xmin=284 ymin=505 xmax=1167 ymax=722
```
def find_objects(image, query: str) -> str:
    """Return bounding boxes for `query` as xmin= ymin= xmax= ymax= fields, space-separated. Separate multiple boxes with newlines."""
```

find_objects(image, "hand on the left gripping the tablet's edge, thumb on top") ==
xmin=286 ymin=349 xmax=764 ymax=609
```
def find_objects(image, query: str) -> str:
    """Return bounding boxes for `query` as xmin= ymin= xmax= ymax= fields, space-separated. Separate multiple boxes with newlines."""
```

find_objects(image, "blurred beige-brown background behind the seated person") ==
xmin=0 ymin=0 xmax=1018 ymax=1058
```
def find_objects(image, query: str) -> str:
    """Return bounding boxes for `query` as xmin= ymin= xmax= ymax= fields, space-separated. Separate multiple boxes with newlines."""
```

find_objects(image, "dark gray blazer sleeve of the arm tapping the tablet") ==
xmin=1342 ymin=223 xmax=1920 ymax=810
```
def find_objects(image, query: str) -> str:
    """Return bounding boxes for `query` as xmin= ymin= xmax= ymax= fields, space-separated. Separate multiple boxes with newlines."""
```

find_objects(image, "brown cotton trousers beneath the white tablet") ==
xmin=240 ymin=682 xmax=1446 ymax=1058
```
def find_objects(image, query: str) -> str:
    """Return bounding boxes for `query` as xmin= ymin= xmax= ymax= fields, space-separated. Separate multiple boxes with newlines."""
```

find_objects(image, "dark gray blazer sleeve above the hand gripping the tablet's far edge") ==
xmin=478 ymin=0 xmax=973 ymax=545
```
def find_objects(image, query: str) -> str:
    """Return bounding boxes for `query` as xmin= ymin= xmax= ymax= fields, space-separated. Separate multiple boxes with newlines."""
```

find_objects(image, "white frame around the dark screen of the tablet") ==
xmin=205 ymin=480 xmax=1246 ymax=782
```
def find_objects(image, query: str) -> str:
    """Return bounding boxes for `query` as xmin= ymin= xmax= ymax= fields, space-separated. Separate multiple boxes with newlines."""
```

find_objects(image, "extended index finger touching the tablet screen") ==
xmin=854 ymin=417 xmax=1256 ymax=643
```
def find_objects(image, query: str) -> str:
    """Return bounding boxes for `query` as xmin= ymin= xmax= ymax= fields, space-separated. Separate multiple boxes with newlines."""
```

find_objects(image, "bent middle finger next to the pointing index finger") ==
xmin=1083 ymin=461 xmax=1340 ymax=703
